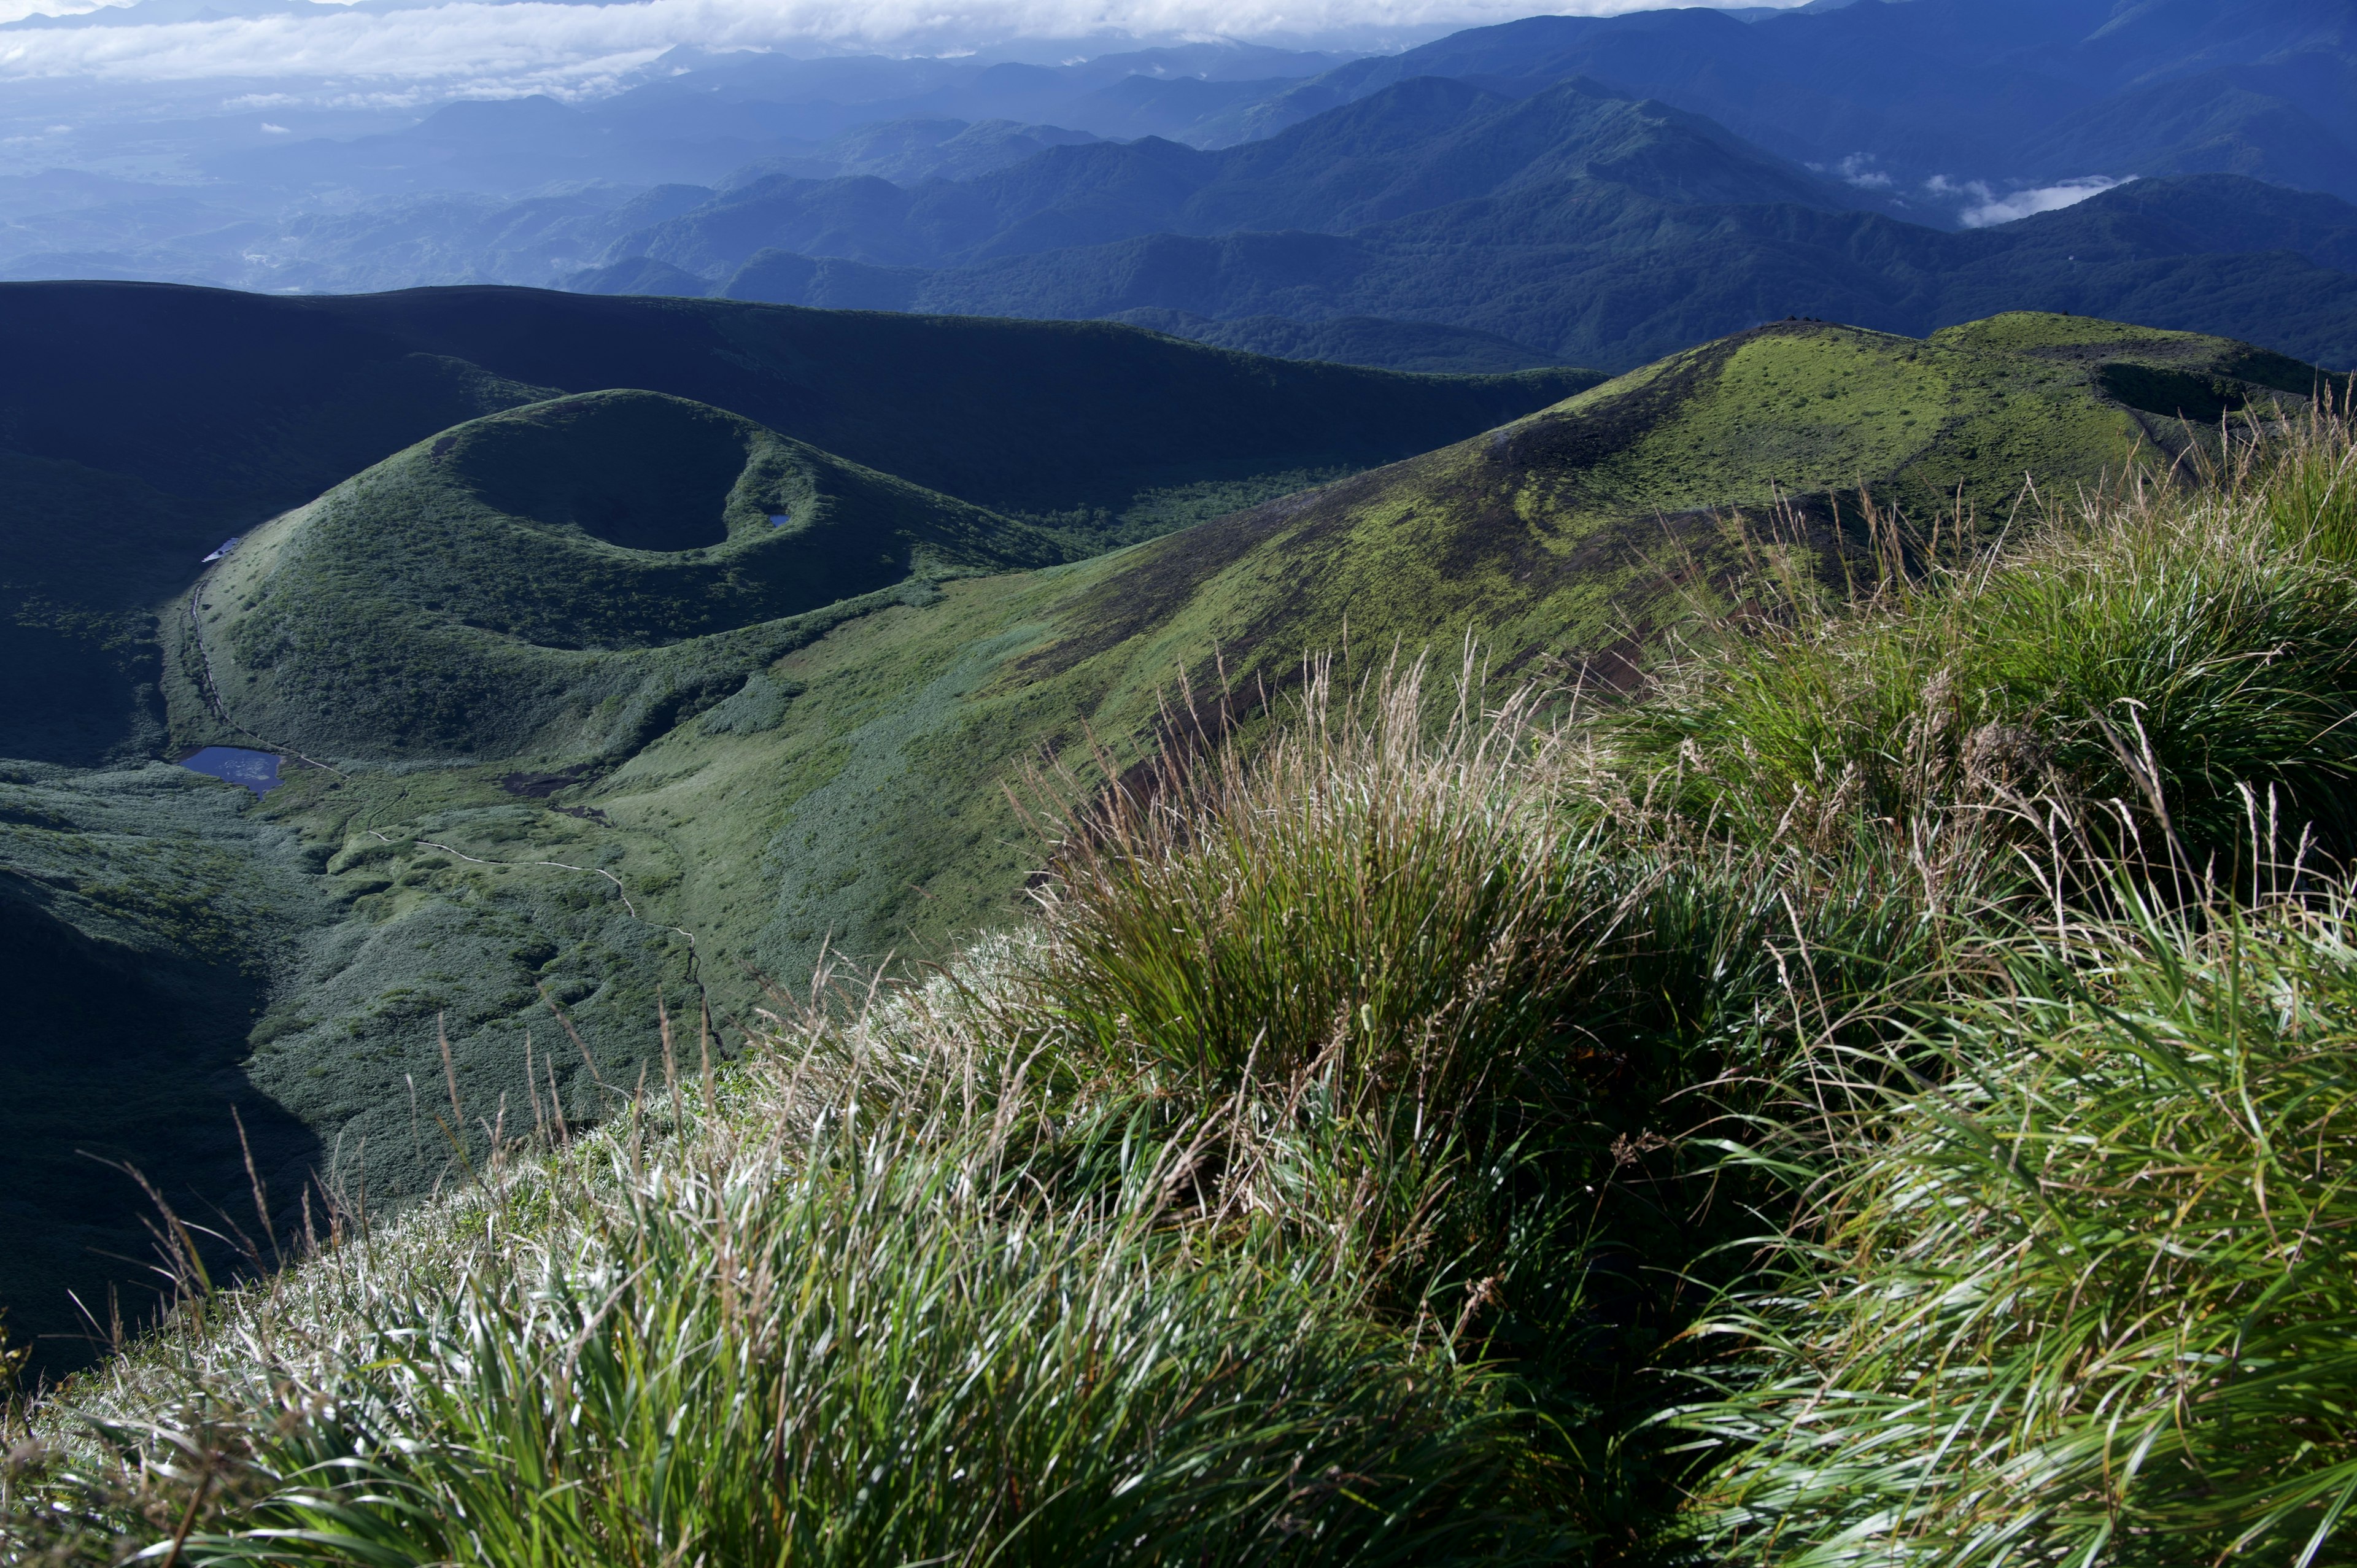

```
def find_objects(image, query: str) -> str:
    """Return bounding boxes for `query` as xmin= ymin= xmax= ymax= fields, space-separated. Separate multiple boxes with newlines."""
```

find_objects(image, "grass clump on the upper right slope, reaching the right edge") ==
xmin=1624 ymin=415 xmax=2357 ymax=856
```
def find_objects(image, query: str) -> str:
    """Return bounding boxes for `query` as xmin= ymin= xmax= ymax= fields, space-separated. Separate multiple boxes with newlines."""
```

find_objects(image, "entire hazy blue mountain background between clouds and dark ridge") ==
xmin=0 ymin=0 xmax=2357 ymax=370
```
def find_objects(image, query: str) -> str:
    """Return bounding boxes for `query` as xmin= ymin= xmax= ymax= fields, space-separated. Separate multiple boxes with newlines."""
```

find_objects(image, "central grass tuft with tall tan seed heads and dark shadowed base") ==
xmin=983 ymin=667 xmax=2018 ymax=1452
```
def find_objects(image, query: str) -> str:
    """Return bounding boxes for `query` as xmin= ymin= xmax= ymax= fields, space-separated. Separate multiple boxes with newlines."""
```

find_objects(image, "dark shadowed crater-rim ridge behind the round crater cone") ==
xmin=0 ymin=283 xmax=1584 ymax=767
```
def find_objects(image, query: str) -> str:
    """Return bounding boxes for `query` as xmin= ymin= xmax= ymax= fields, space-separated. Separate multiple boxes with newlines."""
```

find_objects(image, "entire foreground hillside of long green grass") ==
xmin=7 ymin=382 xmax=2357 ymax=1563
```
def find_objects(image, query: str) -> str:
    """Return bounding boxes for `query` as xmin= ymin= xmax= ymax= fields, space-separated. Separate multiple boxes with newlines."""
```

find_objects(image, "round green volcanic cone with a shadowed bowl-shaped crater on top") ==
xmin=168 ymin=392 xmax=1066 ymax=759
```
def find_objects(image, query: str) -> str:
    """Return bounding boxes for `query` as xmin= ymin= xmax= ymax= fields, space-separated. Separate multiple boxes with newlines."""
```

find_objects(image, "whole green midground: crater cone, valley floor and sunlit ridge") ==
xmin=0 ymin=302 xmax=2317 ymax=1377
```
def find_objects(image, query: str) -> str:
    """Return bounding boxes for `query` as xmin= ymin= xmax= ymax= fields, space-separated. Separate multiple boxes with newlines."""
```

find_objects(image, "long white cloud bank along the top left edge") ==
xmin=0 ymin=0 xmax=1810 ymax=92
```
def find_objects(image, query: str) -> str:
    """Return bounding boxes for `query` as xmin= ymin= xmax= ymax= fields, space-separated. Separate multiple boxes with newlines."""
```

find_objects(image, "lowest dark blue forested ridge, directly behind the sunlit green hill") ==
xmin=674 ymin=174 xmax=2357 ymax=368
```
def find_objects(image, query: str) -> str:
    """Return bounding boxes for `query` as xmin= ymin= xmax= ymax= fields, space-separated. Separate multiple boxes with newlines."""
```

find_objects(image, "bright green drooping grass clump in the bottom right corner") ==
xmin=1687 ymin=887 xmax=2357 ymax=1566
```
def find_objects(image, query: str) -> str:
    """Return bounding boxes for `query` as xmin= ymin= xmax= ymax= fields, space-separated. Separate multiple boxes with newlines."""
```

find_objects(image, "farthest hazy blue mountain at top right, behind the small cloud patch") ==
xmin=1202 ymin=0 xmax=2357 ymax=217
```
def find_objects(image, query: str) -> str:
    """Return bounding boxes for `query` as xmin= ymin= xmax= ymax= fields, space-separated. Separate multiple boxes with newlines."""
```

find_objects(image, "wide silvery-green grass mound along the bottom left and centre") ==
xmin=19 ymin=1014 xmax=1565 ymax=1566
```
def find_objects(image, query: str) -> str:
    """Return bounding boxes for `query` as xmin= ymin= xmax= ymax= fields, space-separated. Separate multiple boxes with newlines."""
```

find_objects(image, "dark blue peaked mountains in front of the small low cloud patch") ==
xmin=573 ymin=78 xmax=2357 ymax=368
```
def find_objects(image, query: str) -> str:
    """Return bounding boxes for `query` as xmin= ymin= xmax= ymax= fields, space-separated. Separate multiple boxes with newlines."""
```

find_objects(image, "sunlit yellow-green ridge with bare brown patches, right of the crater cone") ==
xmin=540 ymin=316 xmax=2315 ymax=974
